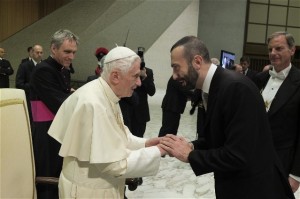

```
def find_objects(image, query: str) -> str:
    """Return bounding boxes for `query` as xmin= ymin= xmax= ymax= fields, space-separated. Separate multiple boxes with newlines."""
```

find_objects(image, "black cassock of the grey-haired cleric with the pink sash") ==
xmin=30 ymin=56 xmax=70 ymax=199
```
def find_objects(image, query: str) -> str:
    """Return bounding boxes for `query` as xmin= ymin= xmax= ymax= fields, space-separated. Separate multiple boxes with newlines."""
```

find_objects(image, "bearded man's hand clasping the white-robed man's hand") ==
xmin=160 ymin=134 xmax=193 ymax=162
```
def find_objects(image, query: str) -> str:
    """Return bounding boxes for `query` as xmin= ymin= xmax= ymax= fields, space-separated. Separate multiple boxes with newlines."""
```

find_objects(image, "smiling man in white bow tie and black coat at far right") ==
xmin=255 ymin=32 xmax=300 ymax=192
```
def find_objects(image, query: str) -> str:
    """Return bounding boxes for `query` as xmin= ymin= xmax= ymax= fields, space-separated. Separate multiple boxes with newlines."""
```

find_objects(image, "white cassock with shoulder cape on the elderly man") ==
xmin=48 ymin=77 xmax=160 ymax=198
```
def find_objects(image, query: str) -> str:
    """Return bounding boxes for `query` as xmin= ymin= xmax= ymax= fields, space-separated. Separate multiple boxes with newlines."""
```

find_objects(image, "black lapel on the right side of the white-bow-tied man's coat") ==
xmin=268 ymin=66 xmax=300 ymax=115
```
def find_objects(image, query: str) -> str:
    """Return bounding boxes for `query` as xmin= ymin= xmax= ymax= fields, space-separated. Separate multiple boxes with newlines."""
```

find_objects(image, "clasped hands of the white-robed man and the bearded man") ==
xmin=146 ymin=134 xmax=194 ymax=163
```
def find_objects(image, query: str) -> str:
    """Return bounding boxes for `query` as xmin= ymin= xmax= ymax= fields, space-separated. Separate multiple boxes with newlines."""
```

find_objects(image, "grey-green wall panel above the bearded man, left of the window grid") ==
xmin=198 ymin=0 xmax=247 ymax=63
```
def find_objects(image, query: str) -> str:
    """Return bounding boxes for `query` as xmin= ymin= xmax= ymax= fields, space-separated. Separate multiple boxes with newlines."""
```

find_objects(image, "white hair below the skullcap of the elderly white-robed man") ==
xmin=101 ymin=55 xmax=141 ymax=81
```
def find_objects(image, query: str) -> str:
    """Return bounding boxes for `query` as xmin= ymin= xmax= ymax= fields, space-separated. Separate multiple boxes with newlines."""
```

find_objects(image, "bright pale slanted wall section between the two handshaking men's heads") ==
xmin=145 ymin=0 xmax=199 ymax=89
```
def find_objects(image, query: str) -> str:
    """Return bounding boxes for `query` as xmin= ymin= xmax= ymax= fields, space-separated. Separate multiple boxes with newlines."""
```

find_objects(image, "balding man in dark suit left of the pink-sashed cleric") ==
xmin=16 ymin=45 xmax=43 ymax=130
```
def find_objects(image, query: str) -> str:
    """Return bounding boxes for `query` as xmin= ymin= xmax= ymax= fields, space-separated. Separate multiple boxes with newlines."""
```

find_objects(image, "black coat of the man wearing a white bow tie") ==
xmin=255 ymin=66 xmax=300 ymax=176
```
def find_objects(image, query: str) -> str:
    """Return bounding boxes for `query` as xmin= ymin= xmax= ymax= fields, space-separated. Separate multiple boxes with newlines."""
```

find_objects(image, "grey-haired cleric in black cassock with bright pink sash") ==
xmin=30 ymin=29 xmax=79 ymax=199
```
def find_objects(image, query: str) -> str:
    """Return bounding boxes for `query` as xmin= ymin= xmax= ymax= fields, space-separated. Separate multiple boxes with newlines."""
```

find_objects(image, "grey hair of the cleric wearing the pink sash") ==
xmin=50 ymin=29 xmax=79 ymax=48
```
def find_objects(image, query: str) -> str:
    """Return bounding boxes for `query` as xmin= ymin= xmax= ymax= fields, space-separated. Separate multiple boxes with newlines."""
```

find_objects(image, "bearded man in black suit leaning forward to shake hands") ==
xmin=161 ymin=36 xmax=294 ymax=199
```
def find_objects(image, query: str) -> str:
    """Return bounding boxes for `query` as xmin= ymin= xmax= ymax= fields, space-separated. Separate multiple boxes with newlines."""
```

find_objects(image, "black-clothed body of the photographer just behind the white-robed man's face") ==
xmin=132 ymin=67 xmax=156 ymax=137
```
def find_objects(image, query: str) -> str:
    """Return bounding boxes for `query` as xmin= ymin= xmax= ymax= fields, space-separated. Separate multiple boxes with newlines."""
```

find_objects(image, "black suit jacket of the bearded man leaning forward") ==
xmin=188 ymin=67 xmax=294 ymax=199
